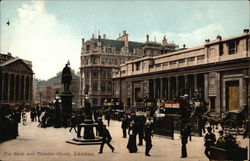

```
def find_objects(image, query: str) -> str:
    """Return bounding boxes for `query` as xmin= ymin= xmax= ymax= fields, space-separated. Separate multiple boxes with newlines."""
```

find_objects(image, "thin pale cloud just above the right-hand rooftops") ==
xmin=134 ymin=23 xmax=226 ymax=48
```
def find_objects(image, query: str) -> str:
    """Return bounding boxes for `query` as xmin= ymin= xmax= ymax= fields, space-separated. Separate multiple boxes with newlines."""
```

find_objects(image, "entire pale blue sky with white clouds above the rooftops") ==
xmin=0 ymin=0 xmax=250 ymax=80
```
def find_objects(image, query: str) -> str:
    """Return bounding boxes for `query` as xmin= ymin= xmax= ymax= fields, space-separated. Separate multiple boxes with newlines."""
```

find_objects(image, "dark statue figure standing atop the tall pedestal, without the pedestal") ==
xmin=62 ymin=64 xmax=72 ymax=92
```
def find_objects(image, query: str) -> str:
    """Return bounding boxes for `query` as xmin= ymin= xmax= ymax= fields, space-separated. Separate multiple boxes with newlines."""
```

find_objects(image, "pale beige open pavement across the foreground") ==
xmin=0 ymin=113 xmax=249 ymax=161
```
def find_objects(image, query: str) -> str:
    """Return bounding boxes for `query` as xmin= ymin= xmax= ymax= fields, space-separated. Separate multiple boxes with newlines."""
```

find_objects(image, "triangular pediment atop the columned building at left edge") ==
xmin=3 ymin=59 xmax=33 ymax=74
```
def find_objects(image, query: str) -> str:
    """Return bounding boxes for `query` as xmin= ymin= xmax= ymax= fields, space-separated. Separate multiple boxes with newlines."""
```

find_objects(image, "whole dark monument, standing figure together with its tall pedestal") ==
xmin=60 ymin=63 xmax=73 ymax=127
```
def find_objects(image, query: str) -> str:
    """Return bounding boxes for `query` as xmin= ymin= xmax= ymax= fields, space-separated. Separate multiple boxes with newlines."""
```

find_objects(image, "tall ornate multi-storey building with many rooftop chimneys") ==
xmin=80 ymin=31 xmax=178 ymax=106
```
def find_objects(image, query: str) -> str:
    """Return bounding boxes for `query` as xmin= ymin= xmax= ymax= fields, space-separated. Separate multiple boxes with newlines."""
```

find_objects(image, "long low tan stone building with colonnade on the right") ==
xmin=113 ymin=29 xmax=250 ymax=113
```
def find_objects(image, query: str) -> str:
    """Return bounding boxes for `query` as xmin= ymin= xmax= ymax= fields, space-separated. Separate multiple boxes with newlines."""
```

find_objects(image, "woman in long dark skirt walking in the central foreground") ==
xmin=127 ymin=120 xmax=138 ymax=153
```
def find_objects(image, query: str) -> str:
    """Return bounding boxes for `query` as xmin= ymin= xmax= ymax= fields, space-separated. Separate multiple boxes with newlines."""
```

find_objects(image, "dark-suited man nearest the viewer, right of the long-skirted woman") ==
xmin=144 ymin=122 xmax=153 ymax=156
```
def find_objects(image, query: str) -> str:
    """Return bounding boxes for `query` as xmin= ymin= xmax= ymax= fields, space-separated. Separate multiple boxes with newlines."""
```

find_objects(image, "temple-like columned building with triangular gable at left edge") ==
xmin=0 ymin=53 xmax=33 ymax=106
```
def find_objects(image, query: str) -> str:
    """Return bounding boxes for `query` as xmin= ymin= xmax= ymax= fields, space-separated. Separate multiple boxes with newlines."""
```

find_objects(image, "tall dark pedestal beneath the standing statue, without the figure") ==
xmin=60 ymin=92 xmax=73 ymax=127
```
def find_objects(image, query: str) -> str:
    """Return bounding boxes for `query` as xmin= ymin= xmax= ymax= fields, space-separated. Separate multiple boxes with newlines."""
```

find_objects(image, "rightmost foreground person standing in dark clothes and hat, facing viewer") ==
xmin=204 ymin=126 xmax=216 ymax=159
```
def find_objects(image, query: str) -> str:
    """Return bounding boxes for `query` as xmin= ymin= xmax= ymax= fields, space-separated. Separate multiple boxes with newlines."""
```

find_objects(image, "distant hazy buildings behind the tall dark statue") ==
xmin=33 ymin=67 xmax=80 ymax=106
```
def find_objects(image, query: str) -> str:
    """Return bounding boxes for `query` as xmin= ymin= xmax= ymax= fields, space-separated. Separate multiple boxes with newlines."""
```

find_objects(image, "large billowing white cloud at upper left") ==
xmin=11 ymin=1 xmax=80 ymax=79
